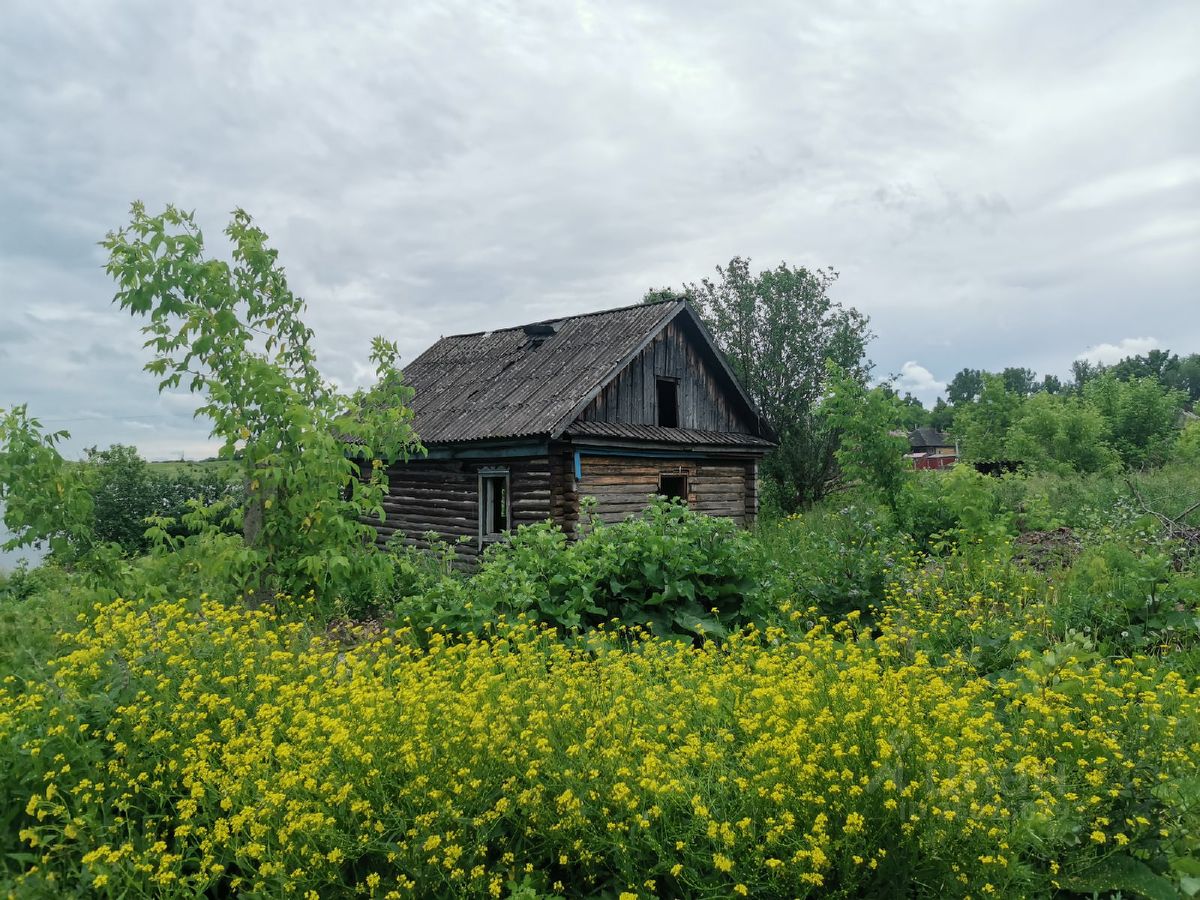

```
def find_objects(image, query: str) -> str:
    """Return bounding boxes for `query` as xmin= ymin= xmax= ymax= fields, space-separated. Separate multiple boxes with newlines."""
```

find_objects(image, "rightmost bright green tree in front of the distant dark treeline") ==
xmin=1084 ymin=372 xmax=1186 ymax=468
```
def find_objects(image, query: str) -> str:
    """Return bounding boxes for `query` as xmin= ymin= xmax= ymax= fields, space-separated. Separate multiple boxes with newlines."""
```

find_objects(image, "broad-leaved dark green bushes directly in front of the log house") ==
xmin=396 ymin=500 xmax=766 ymax=640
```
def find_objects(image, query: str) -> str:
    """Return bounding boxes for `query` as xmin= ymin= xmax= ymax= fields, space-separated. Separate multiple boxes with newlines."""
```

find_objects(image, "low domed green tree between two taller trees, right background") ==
xmin=1007 ymin=394 xmax=1120 ymax=473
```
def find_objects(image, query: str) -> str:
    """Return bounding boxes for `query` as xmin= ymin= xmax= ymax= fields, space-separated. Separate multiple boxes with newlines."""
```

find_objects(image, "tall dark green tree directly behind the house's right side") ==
xmin=667 ymin=257 xmax=871 ymax=510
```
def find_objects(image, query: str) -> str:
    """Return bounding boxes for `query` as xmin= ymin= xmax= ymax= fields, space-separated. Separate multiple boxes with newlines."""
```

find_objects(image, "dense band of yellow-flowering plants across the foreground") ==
xmin=0 ymin=569 xmax=1200 ymax=900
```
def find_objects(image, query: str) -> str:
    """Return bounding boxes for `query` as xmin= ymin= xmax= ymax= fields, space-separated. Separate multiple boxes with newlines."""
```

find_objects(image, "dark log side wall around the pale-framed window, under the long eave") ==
xmin=372 ymin=456 xmax=562 ymax=560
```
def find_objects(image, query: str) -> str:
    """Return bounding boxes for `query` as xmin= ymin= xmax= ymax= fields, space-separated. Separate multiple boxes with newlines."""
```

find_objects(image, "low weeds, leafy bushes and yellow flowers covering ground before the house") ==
xmin=0 ymin=466 xmax=1200 ymax=896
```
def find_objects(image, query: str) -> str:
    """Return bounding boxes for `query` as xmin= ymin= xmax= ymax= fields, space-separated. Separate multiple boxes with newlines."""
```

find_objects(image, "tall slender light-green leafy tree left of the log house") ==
xmin=102 ymin=203 xmax=421 ymax=609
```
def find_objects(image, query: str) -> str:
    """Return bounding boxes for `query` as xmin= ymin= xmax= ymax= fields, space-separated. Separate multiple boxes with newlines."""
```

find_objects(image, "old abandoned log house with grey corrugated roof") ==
xmin=379 ymin=301 xmax=775 ymax=556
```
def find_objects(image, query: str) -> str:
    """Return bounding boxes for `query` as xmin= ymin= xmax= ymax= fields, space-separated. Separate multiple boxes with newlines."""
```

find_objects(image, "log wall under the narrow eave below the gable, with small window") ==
xmin=571 ymin=455 xmax=757 ymax=526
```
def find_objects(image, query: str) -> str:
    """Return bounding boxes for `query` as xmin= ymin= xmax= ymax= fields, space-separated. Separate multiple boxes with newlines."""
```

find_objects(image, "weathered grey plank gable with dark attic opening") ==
xmin=580 ymin=319 xmax=755 ymax=433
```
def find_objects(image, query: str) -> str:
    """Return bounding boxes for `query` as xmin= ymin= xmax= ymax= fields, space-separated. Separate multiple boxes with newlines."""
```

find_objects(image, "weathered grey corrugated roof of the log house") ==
xmin=404 ymin=300 xmax=754 ymax=445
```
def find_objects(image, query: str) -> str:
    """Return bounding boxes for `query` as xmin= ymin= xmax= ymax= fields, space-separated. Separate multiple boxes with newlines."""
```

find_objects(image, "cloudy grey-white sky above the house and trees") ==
xmin=0 ymin=0 xmax=1200 ymax=458
